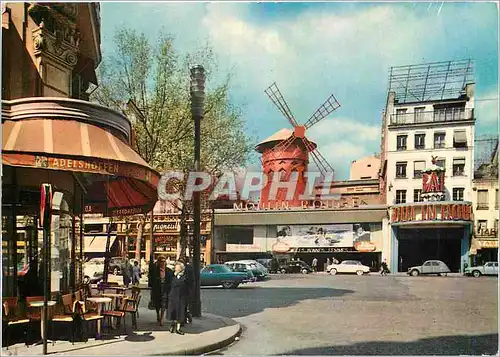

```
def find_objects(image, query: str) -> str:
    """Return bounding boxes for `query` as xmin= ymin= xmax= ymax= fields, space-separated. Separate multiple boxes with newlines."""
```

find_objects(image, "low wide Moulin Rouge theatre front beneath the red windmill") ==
xmin=213 ymin=199 xmax=388 ymax=270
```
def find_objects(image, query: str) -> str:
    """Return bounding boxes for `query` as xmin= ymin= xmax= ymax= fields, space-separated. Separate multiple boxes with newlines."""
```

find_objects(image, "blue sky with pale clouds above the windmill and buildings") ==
xmin=101 ymin=2 xmax=498 ymax=179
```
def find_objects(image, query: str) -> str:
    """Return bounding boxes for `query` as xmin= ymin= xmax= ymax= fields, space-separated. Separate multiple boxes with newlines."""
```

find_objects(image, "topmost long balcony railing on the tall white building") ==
xmin=391 ymin=108 xmax=474 ymax=125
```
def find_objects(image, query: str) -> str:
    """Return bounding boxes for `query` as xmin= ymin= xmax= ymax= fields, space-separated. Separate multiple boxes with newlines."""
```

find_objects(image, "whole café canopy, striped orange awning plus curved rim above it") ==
xmin=2 ymin=98 xmax=159 ymax=216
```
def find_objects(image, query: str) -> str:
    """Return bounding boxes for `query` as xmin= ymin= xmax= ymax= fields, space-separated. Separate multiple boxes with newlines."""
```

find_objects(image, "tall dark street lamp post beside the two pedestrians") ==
xmin=190 ymin=65 xmax=205 ymax=317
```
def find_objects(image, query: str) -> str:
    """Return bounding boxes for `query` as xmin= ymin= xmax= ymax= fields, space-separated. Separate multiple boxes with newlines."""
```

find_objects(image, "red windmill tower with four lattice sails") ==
xmin=255 ymin=83 xmax=340 ymax=207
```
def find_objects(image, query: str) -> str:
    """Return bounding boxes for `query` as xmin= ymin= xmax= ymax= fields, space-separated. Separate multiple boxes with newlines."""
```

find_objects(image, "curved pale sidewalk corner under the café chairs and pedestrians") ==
xmin=2 ymin=308 xmax=241 ymax=356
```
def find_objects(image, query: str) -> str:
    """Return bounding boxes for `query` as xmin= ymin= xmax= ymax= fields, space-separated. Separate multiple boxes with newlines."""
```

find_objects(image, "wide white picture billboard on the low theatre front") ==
xmin=273 ymin=223 xmax=371 ymax=253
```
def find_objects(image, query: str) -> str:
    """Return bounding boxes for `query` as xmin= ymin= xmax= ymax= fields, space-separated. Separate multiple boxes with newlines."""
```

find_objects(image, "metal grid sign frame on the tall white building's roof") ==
xmin=389 ymin=59 xmax=474 ymax=103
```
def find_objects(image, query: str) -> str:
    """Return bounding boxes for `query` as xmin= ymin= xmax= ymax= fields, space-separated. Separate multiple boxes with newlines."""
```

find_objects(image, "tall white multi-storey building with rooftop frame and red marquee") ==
xmin=381 ymin=61 xmax=475 ymax=272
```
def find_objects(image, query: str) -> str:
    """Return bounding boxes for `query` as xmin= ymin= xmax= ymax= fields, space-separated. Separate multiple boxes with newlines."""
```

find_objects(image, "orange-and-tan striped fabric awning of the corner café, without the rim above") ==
xmin=2 ymin=119 xmax=160 ymax=216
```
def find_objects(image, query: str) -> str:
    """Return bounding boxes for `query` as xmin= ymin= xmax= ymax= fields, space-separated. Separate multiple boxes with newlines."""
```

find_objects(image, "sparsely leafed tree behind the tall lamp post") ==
xmin=91 ymin=28 xmax=253 ymax=259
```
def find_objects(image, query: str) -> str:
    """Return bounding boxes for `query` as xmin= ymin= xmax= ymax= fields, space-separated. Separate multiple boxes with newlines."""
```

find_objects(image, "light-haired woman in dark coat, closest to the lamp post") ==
xmin=167 ymin=262 xmax=189 ymax=335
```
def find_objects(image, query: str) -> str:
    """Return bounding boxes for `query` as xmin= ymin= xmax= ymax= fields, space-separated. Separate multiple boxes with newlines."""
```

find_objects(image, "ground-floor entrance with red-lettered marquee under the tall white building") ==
xmin=390 ymin=201 xmax=473 ymax=272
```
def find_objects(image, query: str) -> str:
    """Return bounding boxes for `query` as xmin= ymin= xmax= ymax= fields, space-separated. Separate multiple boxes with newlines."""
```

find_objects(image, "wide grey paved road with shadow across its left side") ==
xmin=198 ymin=275 xmax=498 ymax=355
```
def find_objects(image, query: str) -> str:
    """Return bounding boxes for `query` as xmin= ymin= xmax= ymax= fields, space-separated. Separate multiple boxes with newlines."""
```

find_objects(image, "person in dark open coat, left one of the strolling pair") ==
xmin=149 ymin=256 xmax=174 ymax=326
